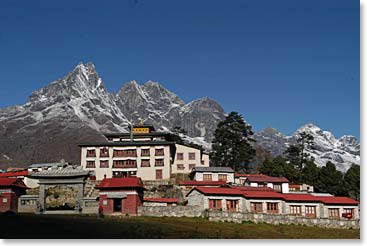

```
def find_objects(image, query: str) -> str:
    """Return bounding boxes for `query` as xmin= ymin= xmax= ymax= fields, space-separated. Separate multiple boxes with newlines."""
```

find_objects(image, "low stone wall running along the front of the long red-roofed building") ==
xmin=208 ymin=211 xmax=360 ymax=229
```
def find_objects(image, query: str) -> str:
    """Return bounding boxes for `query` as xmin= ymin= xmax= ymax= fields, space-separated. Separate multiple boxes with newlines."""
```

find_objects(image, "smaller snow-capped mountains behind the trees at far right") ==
xmin=255 ymin=123 xmax=360 ymax=172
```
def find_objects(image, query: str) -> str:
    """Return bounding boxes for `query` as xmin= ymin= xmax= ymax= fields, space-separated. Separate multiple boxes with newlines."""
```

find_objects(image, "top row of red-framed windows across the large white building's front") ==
xmin=87 ymin=148 xmax=164 ymax=157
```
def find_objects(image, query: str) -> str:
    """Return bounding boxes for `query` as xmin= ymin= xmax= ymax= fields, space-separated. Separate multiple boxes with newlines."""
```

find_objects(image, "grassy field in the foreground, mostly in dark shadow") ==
xmin=0 ymin=214 xmax=360 ymax=239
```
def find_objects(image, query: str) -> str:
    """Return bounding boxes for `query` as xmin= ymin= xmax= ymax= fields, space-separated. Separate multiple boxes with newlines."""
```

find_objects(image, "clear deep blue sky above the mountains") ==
xmin=0 ymin=0 xmax=360 ymax=137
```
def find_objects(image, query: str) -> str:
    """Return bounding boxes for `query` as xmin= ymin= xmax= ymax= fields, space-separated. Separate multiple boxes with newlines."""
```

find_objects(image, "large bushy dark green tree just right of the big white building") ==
xmin=211 ymin=112 xmax=255 ymax=171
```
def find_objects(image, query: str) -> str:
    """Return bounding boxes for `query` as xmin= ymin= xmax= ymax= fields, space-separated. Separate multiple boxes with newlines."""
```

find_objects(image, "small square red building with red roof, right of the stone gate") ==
xmin=96 ymin=177 xmax=144 ymax=214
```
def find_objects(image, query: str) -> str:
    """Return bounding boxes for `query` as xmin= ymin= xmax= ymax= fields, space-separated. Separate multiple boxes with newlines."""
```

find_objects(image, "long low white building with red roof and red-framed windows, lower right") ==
xmin=186 ymin=186 xmax=359 ymax=219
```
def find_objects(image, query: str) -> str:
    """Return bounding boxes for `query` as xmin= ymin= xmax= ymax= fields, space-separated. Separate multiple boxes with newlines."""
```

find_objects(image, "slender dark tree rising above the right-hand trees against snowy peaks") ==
xmin=285 ymin=132 xmax=314 ymax=180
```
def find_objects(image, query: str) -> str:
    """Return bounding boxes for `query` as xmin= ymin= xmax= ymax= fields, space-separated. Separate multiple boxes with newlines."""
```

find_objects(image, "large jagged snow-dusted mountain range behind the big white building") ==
xmin=0 ymin=63 xmax=225 ymax=167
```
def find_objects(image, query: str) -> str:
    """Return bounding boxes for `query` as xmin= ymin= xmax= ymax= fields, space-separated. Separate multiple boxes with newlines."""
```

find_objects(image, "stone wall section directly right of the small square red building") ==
xmin=138 ymin=206 xmax=204 ymax=217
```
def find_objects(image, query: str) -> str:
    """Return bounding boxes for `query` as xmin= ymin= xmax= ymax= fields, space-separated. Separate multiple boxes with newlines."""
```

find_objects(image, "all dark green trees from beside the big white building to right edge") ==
xmin=210 ymin=112 xmax=360 ymax=200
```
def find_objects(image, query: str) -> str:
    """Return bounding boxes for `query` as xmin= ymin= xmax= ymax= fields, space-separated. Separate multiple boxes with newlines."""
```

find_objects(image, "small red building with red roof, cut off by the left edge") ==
xmin=0 ymin=177 xmax=27 ymax=212
